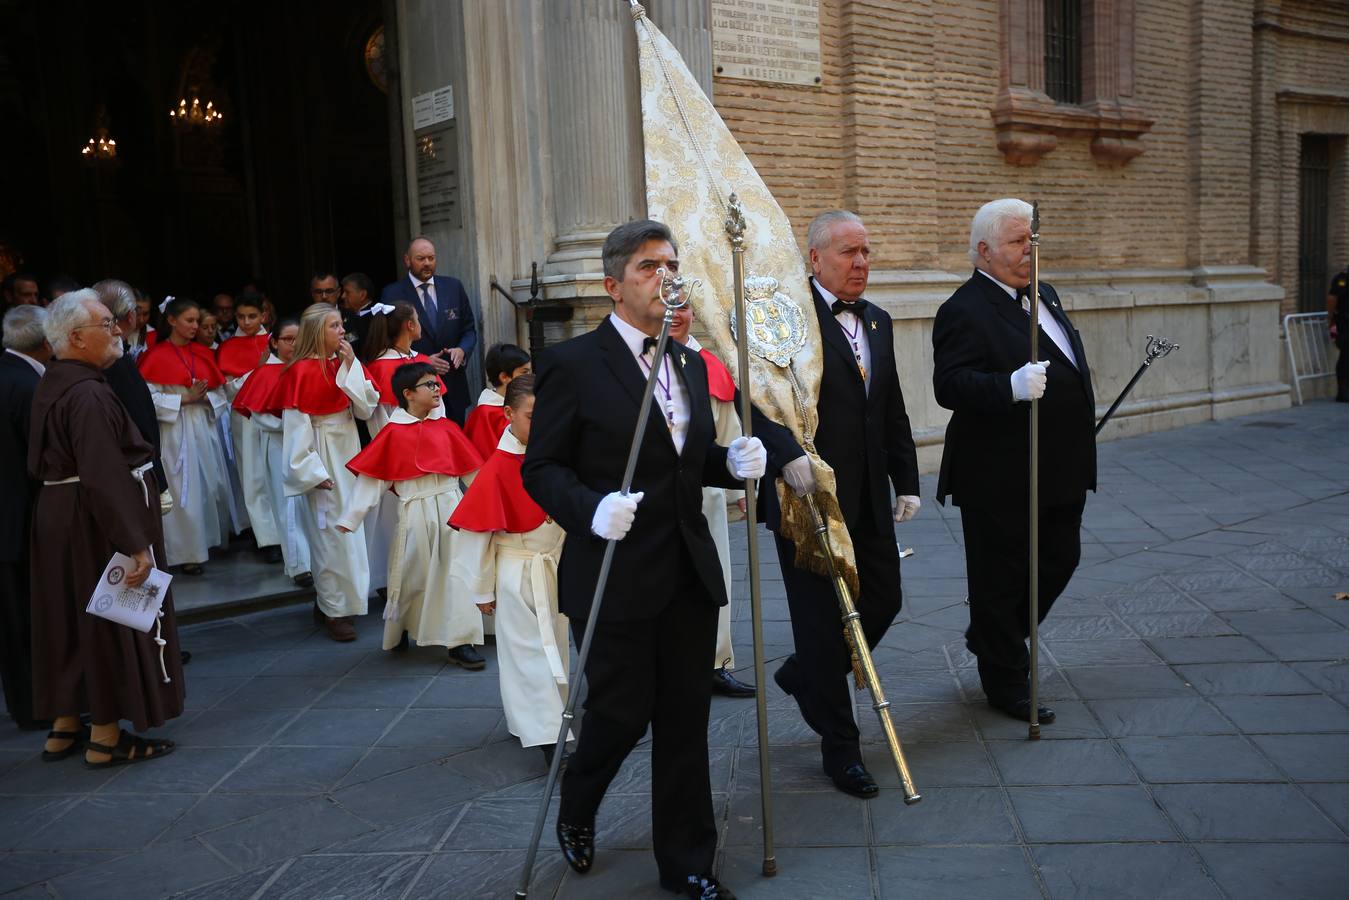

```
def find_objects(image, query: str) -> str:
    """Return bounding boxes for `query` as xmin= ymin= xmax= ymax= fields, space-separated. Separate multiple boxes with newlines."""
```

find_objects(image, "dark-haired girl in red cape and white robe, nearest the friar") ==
xmin=136 ymin=298 xmax=231 ymax=575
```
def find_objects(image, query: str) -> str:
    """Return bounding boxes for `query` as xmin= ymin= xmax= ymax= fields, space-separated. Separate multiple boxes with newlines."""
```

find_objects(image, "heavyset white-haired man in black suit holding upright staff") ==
xmin=932 ymin=200 xmax=1095 ymax=723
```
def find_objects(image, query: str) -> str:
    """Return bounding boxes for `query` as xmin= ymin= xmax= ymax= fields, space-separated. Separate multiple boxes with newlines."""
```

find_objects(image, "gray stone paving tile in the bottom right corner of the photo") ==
xmin=1195 ymin=842 xmax=1349 ymax=900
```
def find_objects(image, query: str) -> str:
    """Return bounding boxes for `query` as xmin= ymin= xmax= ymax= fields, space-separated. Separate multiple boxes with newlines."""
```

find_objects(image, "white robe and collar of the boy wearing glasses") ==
xmin=339 ymin=409 xmax=483 ymax=650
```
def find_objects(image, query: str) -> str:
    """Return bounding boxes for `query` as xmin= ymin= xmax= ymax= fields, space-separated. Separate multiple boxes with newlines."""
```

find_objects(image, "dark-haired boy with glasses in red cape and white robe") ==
xmin=337 ymin=363 xmax=486 ymax=661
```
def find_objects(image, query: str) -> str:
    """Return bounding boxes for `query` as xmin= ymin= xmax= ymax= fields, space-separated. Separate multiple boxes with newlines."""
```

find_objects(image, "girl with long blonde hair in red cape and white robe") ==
xmin=267 ymin=304 xmax=379 ymax=641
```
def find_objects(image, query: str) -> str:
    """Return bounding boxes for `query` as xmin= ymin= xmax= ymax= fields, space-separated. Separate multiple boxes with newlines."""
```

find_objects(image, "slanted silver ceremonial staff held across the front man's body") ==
xmin=515 ymin=267 xmax=700 ymax=897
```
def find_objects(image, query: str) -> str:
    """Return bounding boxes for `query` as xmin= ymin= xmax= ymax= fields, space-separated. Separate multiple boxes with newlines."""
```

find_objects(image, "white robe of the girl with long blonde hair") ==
xmin=281 ymin=363 xmax=379 ymax=618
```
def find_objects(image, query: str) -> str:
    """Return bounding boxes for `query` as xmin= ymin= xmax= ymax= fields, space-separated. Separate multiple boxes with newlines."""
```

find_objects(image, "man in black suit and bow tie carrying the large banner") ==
xmin=764 ymin=210 xmax=921 ymax=799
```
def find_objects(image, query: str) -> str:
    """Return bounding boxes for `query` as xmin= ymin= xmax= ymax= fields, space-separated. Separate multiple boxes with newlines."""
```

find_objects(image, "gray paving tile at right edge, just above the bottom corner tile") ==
xmin=1153 ymin=784 xmax=1344 ymax=841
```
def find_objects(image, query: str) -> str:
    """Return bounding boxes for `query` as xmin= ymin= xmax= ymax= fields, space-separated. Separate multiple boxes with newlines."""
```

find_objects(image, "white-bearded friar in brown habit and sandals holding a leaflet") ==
xmin=28 ymin=290 xmax=183 ymax=766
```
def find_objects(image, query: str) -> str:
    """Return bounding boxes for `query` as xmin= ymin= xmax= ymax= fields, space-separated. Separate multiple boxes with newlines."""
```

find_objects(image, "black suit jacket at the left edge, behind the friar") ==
xmin=0 ymin=351 xmax=38 ymax=563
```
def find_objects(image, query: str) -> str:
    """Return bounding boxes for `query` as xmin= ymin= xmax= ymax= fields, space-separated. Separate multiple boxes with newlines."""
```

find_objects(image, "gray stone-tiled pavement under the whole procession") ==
xmin=0 ymin=403 xmax=1349 ymax=900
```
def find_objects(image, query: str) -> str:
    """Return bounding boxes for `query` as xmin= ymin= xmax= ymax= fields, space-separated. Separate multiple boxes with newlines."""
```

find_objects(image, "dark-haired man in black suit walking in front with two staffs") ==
xmin=523 ymin=220 xmax=765 ymax=900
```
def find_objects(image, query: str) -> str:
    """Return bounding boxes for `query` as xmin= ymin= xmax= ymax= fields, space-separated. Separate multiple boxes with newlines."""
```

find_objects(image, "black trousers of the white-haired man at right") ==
xmin=960 ymin=495 xmax=1086 ymax=703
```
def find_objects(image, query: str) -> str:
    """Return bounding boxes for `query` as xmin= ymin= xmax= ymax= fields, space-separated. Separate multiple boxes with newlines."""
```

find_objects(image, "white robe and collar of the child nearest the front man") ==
xmin=452 ymin=429 xmax=569 ymax=748
